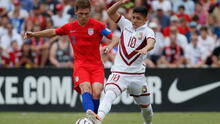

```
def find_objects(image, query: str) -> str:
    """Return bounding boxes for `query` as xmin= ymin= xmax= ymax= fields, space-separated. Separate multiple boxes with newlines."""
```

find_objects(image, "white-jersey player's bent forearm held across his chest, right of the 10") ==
xmin=136 ymin=38 xmax=155 ymax=54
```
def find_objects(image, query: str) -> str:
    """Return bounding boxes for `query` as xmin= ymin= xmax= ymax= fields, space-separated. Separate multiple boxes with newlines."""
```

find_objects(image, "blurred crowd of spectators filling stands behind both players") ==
xmin=0 ymin=0 xmax=220 ymax=68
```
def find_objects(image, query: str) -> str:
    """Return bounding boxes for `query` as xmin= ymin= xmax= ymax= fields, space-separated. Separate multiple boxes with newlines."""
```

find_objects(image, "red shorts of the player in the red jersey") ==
xmin=73 ymin=66 xmax=104 ymax=93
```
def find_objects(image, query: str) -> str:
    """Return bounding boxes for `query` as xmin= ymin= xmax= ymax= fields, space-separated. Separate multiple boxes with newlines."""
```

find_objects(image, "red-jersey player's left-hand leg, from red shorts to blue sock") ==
xmin=73 ymin=66 xmax=94 ymax=111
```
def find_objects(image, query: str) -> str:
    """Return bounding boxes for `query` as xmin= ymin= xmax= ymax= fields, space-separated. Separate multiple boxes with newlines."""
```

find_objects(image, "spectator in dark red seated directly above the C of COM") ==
xmin=16 ymin=41 xmax=37 ymax=68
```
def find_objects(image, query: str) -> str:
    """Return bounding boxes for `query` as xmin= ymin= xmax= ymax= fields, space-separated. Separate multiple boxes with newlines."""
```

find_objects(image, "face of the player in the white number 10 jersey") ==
xmin=131 ymin=13 xmax=147 ymax=28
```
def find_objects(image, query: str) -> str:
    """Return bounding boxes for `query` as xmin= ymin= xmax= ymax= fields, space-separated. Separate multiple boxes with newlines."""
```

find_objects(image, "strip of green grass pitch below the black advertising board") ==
xmin=0 ymin=112 xmax=220 ymax=124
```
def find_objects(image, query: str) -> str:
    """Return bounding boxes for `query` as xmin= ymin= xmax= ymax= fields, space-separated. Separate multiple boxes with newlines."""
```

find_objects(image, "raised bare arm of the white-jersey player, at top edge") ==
xmin=107 ymin=0 xmax=129 ymax=22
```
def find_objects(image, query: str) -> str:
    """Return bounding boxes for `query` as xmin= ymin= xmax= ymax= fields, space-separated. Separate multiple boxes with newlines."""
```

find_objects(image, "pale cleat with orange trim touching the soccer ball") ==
xmin=86 ymin=110 xmax=102 ymax=124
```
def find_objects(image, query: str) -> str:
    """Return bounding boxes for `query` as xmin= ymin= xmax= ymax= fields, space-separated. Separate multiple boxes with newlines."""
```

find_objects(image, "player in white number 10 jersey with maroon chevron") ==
xmin=87 ymin=0 xmax=155 ymax=124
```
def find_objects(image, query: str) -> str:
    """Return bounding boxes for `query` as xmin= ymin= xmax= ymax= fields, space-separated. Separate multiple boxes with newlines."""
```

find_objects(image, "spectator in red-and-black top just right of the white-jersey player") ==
xmin=157 ymin=34 xmax=186 ymax=67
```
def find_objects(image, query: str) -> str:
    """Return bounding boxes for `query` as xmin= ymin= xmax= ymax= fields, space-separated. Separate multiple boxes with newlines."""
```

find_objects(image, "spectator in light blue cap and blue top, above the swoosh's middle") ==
xmin=185 ymin=21 xmax=199 ymax=43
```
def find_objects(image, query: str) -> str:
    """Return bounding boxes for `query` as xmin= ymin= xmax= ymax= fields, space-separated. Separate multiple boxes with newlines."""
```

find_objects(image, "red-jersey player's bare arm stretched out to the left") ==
xmin=24 ymin=29 xmax=56 ymax=40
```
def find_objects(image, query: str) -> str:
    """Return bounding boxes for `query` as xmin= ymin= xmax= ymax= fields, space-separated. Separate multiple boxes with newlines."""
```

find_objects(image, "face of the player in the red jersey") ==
xmin=76 ymin=8 xmax=90 ymax=25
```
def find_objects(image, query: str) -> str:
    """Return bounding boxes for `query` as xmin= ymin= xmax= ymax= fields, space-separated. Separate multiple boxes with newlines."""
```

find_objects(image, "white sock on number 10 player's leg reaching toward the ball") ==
xmin=98 ymin=90 xmax=117 ymax=119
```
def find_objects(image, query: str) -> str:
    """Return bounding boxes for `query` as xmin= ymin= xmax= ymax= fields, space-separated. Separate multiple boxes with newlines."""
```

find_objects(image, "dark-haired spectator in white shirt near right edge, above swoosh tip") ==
xmin=198 ymin=26 xmax=215 ymax=55
